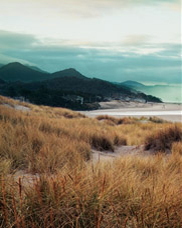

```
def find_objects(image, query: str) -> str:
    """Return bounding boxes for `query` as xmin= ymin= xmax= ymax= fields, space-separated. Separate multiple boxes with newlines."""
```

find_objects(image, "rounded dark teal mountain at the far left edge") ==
xmin=0 ymin=62 xmax=49 ymax=82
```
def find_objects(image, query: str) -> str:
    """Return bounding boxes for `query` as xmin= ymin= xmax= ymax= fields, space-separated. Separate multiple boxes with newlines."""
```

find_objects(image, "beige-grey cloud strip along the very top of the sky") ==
xmin=1 ymin=0 xmax=180 ymax=18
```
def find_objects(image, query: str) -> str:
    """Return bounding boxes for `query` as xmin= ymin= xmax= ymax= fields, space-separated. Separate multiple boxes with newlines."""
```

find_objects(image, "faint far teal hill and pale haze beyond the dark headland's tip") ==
xmin=120 ymin=81 xmax=182 ymax=103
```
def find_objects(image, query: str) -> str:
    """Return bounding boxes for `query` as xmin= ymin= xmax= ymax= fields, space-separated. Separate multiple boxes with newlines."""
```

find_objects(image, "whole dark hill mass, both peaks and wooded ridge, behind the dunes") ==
xmin=0 ymin=63 xmax=161 ymax=109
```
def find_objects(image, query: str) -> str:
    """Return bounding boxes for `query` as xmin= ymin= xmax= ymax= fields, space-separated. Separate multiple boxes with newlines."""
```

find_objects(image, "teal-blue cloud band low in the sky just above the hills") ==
xmin=0 ymin=31 xmax=181 ymax=83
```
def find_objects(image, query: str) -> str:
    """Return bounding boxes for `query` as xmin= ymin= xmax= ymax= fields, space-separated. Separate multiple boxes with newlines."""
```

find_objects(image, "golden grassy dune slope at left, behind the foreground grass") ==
xmin=0 ymin=100 xmax=126 ymax=172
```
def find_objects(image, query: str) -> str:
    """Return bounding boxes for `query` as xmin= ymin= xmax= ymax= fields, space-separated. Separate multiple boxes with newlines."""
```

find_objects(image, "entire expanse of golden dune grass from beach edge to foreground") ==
xmin=0 ymin=97 xmax=182 ymax=228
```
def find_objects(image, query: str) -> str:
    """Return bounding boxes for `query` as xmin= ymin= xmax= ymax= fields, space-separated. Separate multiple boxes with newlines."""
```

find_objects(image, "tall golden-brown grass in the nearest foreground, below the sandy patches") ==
xmin=0 ymin=156 xmax=182 ymax=228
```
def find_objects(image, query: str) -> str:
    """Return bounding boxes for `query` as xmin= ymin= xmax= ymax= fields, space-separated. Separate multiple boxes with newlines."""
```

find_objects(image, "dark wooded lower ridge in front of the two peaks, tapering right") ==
xmin=0 ymin=73 xmax=161 ymax=110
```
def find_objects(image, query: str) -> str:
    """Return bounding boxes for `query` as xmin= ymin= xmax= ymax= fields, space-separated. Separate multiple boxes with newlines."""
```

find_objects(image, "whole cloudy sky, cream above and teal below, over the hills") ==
xmin=0 ymin=0 xmax=182 ymax=84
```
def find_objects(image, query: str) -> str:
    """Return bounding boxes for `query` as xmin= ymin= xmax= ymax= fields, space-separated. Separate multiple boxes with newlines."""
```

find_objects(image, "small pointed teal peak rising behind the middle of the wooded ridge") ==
xmin=51 ymin=68 xmax=86 ymax=78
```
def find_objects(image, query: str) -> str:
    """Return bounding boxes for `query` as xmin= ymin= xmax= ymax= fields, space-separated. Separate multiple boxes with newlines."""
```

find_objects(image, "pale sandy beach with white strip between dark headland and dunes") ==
xmin=82 ymin=100 xmax=182 ymax=122
